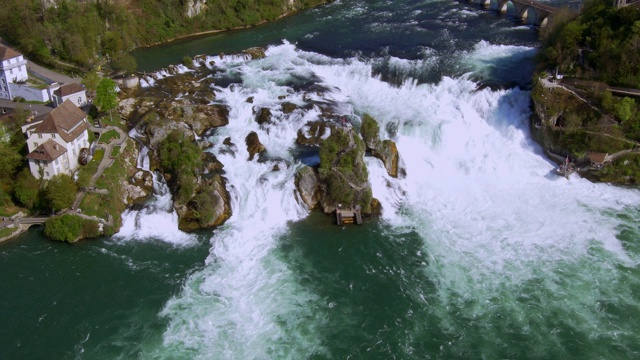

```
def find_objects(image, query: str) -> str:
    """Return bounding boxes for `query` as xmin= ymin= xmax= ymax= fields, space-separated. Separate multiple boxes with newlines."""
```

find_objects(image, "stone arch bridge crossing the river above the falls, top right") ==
xmin=467 ymin=0 xmax=560 ymax=27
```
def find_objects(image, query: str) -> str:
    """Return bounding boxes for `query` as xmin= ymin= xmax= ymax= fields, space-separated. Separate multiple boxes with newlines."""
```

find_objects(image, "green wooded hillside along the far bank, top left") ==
xmin=0 ymin=0 xmax=326 ymax=70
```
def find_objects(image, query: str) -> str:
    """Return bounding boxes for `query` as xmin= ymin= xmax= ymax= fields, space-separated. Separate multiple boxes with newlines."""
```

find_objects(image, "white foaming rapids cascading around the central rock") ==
xmin=129 ymin=43 xmax=640 ymax=359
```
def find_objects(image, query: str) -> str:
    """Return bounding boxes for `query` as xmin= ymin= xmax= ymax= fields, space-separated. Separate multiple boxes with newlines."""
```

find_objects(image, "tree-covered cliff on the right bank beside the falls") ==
xmin=531 ymin=0 xmax=640 ymax=183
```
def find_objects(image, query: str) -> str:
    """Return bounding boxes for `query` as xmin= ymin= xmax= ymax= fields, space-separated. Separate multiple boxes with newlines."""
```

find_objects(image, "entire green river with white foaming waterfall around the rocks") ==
xmin=0 ymin=0 xmax=640 ymax=359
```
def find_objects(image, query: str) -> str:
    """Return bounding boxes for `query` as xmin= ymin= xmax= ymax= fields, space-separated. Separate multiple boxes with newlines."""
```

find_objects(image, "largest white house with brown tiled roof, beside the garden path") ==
xmin=22 ymin=100 xmax=89 ymax=179
